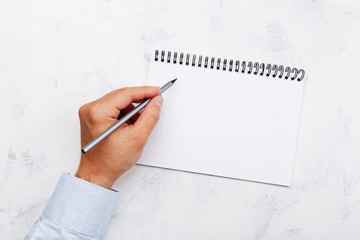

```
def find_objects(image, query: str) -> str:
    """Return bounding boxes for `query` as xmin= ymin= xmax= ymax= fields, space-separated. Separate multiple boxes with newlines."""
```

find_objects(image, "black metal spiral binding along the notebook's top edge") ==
xmin=155 ymin=50 xmax=305 ymax=81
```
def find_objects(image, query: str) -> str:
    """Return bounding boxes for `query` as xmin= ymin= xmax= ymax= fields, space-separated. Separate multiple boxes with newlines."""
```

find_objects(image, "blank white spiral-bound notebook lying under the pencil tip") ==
xmin=138 ymin=50 xmax=305 ymax=186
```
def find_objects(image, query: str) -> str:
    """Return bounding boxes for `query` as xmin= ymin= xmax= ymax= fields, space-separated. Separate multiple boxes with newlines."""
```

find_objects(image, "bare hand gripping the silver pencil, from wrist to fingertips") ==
xmin=75 ymin=86 xmax=163 ymax=189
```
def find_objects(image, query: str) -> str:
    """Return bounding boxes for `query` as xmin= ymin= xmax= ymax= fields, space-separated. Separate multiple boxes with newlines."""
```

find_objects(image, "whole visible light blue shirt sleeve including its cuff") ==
xmin=25 ymin=173 xmax=119 ymax=240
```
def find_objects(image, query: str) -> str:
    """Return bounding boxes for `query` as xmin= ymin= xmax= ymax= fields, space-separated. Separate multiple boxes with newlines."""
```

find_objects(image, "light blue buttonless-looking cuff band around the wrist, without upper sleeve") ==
xmin=42 ymin=173 xmax=119 ymax=237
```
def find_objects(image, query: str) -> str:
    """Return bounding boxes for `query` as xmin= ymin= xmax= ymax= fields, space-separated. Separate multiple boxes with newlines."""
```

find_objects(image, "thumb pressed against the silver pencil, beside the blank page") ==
xmin=134 ymin=95 xmax=163 ymax=137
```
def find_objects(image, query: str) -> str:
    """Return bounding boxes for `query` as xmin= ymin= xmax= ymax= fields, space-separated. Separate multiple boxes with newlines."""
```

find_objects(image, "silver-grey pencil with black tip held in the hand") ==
xmin=81 ymin=78 xmax=177 ymax=154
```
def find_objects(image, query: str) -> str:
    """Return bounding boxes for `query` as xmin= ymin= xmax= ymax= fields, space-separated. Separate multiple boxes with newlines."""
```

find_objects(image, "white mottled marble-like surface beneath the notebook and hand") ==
xmin=0 ymin=0 xmax=360 ymax=240
